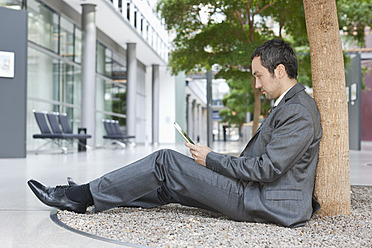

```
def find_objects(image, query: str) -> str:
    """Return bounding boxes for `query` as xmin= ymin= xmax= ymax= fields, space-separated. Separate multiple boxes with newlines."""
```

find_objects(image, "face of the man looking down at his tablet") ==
xmin=252 ymin=57 xmax=280 ymax=100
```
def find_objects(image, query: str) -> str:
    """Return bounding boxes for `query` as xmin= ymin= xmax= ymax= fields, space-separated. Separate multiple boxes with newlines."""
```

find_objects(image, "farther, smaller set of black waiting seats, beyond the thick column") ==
xmin=102 ymin=119 xmax=136 ymax=148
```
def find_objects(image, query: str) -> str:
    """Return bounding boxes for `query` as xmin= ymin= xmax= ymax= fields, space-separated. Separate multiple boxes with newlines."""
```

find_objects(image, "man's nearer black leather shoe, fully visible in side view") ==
xmin=27 ymin=179 xmax=87 ymax=214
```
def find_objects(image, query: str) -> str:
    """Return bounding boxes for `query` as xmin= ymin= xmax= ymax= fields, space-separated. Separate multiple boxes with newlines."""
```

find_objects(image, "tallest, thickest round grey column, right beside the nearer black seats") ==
xmin=81 ymin=4 xmax=96 ymax=147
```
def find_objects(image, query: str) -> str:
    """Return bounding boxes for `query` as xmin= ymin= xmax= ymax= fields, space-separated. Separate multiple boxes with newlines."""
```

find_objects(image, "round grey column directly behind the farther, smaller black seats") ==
xmin=127 ymin=43 xmax=137 ymax=139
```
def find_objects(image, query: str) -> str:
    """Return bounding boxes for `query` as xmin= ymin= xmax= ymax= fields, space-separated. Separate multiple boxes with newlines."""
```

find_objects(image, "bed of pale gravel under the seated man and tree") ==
xmin=57 ymin=186 xmax=372 ymax=248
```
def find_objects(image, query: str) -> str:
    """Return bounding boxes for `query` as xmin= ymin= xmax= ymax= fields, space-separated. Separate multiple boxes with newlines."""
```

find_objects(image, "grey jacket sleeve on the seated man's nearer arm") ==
xmin=206 ymin=104 xmax=314 ymax=182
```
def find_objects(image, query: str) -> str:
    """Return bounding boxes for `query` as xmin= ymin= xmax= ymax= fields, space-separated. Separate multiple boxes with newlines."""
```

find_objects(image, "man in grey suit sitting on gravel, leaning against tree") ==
xmin=28 ymin=40 xmax=322 ymax=227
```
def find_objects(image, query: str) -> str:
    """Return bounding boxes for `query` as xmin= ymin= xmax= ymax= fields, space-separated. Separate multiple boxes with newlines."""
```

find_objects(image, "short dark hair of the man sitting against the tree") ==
xmin=251 ymin=39 xmax=297 ymax=79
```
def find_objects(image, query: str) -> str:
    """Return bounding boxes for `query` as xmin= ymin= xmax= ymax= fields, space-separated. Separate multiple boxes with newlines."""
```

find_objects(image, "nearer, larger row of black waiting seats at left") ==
xmin=33 ymin=111 xmax=92 ymax=153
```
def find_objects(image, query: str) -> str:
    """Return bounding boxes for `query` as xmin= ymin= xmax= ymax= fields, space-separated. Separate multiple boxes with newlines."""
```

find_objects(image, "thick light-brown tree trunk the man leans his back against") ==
xmin=303 ymin=0 xmax=351 ymax=216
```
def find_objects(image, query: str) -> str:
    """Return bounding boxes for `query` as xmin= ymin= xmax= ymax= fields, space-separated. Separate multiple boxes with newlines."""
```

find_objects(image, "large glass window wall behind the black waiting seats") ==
xmin=22 ymin=0 xmax=126 ymax=150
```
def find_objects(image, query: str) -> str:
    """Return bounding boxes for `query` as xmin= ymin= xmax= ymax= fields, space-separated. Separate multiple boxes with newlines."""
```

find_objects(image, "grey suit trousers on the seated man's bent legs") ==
xmin=89 ymin=149 xmax=253 ymax=221
